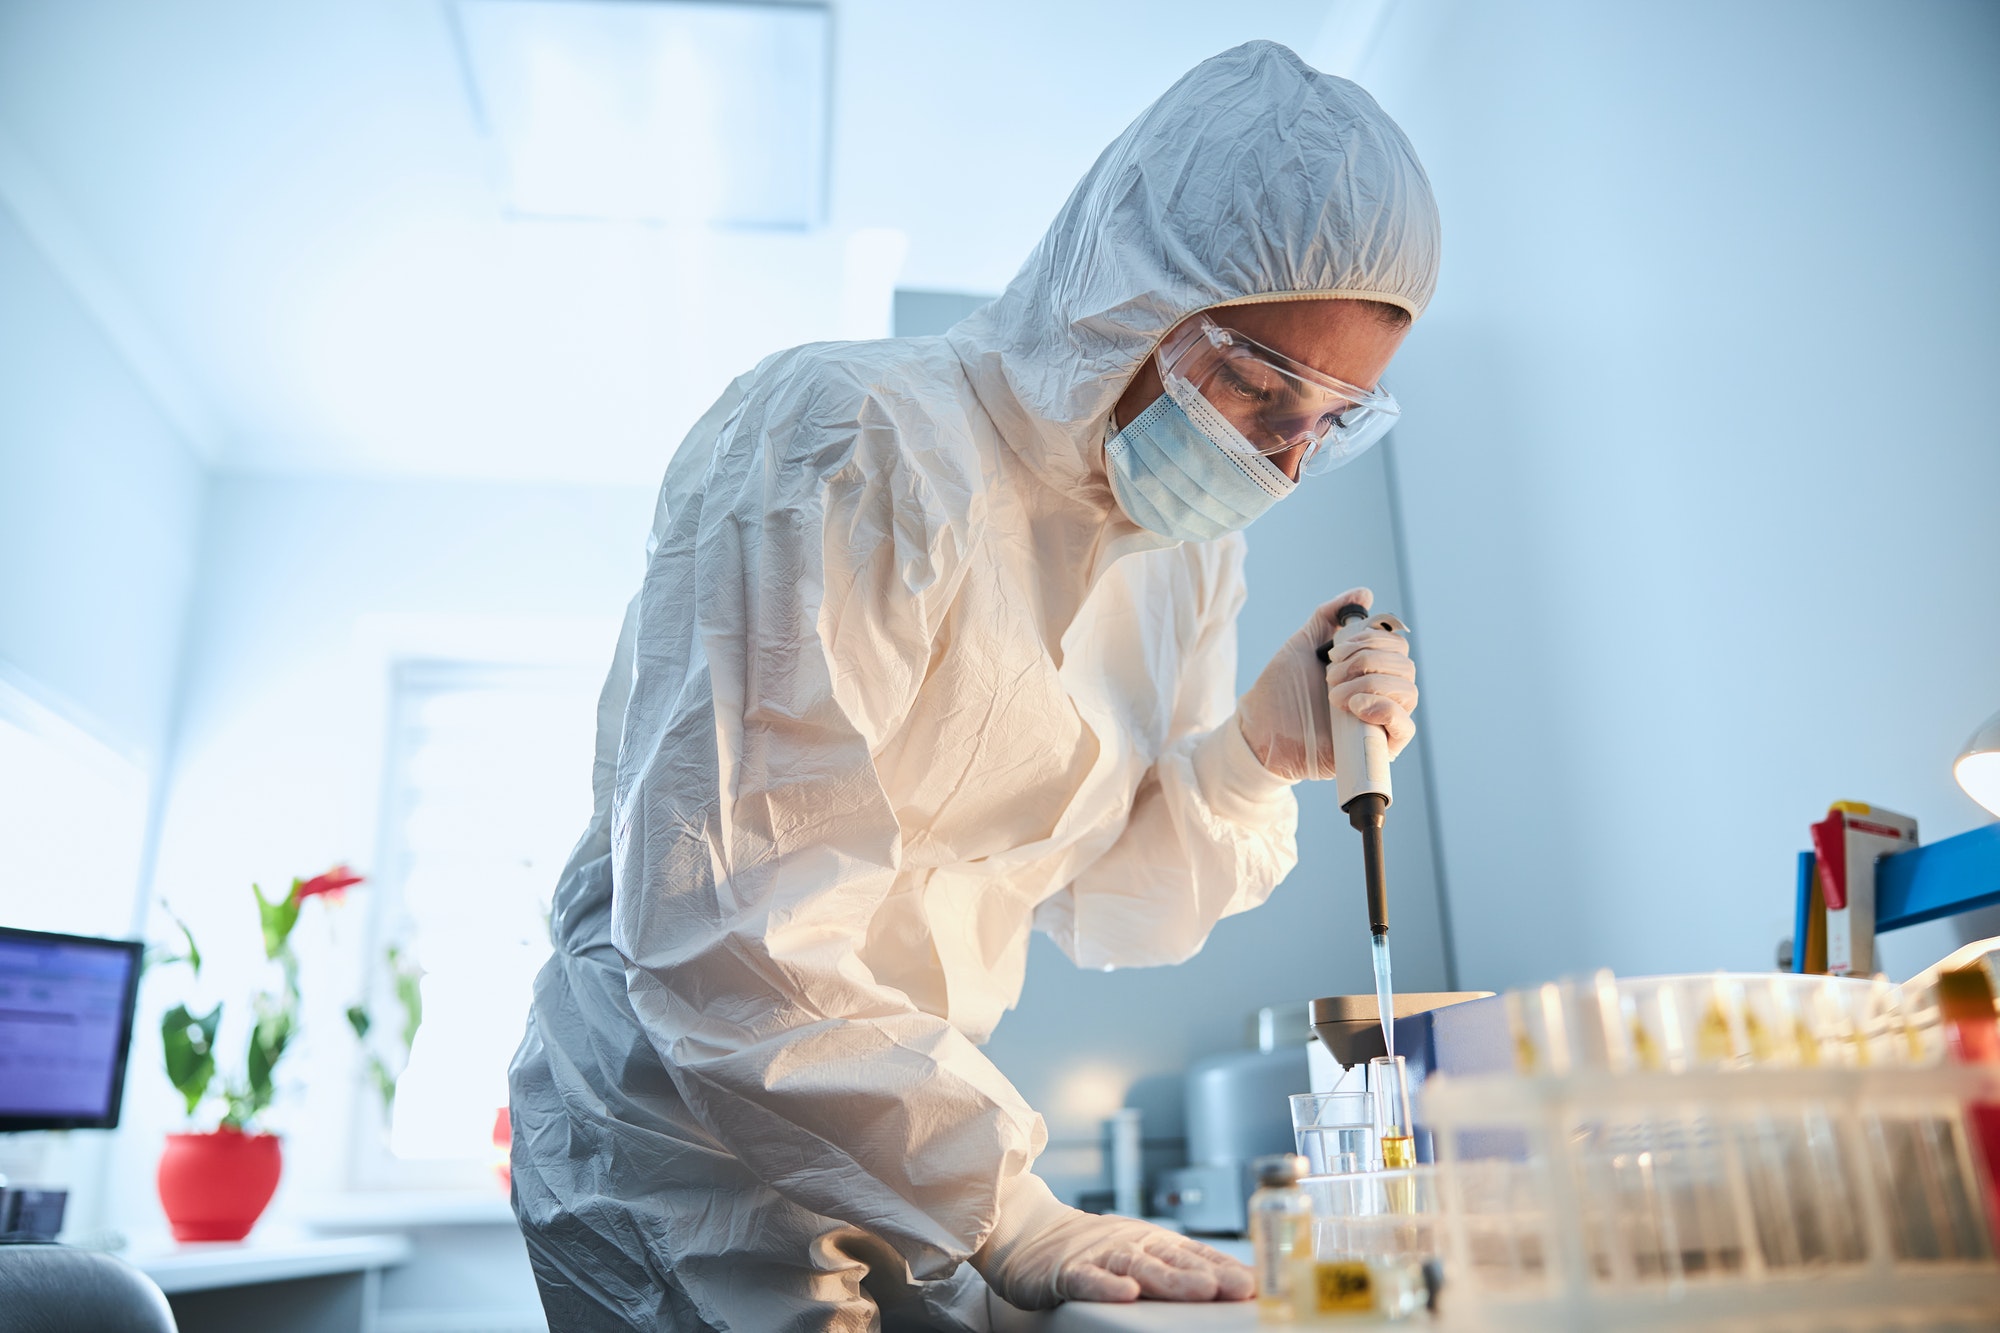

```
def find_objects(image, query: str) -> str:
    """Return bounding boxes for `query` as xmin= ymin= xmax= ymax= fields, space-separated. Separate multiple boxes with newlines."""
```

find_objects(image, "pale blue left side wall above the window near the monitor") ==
xmin=0 ymin=202 xmax=202 ymax=804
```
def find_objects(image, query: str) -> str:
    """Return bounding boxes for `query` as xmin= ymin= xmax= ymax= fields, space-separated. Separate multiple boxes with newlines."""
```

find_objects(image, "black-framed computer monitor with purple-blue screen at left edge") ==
xmin=0 ymin=927 xmax=144 ymax=1133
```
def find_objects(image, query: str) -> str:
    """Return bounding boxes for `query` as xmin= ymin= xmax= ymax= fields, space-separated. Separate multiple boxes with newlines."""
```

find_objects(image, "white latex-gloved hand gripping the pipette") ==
xmin=1236 ymin=588 xmax=1416 ymax=783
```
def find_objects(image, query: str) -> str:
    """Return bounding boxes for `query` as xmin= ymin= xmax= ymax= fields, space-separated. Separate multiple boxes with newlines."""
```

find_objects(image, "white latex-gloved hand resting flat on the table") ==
xmin=972 ymin=1175 xmax=1256 ymax=1309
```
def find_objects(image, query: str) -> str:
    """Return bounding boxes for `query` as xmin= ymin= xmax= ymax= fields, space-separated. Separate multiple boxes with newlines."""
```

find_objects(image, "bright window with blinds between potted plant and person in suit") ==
xmin=356 ymin=662 xmax=598 ymax=1187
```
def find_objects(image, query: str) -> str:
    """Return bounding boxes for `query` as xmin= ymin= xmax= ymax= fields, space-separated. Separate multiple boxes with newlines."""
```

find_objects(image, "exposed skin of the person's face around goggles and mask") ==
xmin=1112 ymin=298 xmax=1410 ymax=480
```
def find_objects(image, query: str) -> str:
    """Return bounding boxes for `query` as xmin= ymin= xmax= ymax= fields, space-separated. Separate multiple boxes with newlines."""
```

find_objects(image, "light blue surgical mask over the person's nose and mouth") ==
xmin=1104 ymin=394 xmax=1298 ymax=542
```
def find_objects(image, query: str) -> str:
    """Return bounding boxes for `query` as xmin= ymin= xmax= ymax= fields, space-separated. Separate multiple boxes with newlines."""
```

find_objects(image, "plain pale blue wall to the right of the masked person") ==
xmin=1360 ymin=0 xmax=2000 ymax=987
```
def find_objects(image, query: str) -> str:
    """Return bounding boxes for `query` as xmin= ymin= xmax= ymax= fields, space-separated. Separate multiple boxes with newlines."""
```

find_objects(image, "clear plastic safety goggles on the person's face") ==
xmin=1158 ymin=316 xmax=1402 ymax=476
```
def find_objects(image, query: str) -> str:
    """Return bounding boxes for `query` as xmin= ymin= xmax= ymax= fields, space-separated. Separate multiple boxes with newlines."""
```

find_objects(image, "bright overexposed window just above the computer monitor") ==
xmin=0 ymin=681 xmax=146 ymax=939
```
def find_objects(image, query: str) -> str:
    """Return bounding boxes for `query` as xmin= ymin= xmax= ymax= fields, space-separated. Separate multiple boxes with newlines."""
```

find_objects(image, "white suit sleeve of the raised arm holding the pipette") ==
xmin=1036 ymin=538 xmax=1298 ymax=967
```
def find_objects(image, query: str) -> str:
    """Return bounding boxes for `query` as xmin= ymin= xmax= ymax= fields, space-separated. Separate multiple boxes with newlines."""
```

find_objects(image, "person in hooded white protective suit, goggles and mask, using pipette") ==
xmin=512 ymin=42 xmax=1438 ymax=1333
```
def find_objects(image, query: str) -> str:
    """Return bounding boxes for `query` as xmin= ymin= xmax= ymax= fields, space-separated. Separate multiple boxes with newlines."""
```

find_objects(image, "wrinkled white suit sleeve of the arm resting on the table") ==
xmin=612 ymin=374 xmax=1046 ymax=1277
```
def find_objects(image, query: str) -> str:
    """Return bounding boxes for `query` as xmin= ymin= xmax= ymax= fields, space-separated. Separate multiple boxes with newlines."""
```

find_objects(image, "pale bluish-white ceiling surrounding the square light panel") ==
xmin=0 ymin=0 xmax=1332 ymax=482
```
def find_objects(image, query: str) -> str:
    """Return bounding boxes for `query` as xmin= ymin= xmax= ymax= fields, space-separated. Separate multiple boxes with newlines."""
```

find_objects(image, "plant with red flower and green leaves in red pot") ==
xmin=158 ymin=865 xmax=362 ymax=1241
